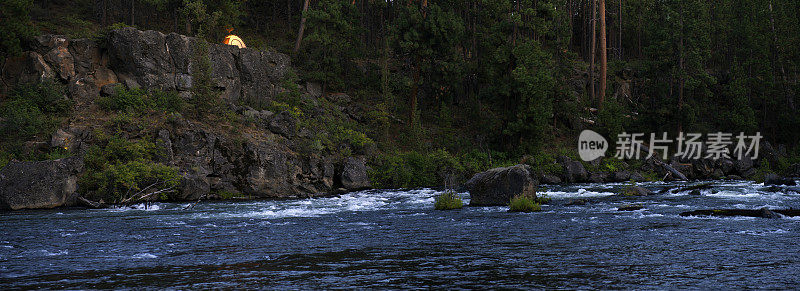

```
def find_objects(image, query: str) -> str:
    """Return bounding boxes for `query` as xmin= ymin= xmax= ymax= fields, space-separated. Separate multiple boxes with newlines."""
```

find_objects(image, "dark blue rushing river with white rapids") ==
xmin=0 ymin=182 xmax=800 ymax=289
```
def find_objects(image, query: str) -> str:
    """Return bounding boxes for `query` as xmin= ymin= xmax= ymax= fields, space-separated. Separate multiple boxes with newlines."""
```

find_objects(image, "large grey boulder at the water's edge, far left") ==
xmin=0 ymin=157 xmax=83 ymax=210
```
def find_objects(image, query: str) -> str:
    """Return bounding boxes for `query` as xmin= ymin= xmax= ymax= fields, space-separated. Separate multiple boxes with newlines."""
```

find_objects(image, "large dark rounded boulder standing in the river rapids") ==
xmin=464 ymin=165 xmax=537 ymax=206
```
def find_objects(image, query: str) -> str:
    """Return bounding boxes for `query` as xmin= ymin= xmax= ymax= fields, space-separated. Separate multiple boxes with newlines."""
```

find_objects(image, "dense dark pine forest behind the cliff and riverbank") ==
xmin=0 ymin=0 xmax=800 ymax=184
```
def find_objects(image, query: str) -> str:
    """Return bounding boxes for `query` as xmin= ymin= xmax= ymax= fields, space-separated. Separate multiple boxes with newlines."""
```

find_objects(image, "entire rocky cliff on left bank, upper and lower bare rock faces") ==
xmin=0 ymin=28 xmax=370 ymax=208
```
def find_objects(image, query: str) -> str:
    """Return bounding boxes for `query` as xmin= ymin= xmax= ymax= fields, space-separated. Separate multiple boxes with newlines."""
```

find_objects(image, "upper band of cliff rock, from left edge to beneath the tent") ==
xmin=0 ymin=28 xmax=291 ymax=102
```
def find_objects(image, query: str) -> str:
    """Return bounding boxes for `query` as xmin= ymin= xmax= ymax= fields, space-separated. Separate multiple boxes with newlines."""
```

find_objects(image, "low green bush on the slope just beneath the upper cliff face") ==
xmin=97 ymin=86 xmax=183 ymax=112
